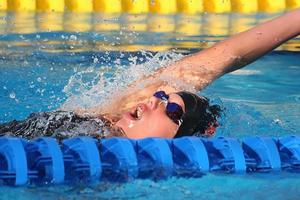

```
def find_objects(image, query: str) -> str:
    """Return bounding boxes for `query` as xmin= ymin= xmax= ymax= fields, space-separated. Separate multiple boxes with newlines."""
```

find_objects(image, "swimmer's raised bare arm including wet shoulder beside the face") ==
xmin=84 ymin=9 xmax=300 ymax=113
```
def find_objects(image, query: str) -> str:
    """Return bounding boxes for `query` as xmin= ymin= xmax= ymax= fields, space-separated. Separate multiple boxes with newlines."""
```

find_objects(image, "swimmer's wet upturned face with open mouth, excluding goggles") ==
xmin=116 ymin=93 xmax=184 ymax=139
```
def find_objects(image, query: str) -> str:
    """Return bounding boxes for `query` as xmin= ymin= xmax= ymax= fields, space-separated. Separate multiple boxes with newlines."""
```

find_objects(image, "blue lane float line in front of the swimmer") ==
xmin=0 ymin=136 xmax=300 ymax=185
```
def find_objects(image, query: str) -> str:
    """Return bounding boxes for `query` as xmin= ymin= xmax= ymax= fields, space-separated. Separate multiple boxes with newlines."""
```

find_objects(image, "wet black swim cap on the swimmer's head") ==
xmin=175 ymin=91 xmax=221 ymax=138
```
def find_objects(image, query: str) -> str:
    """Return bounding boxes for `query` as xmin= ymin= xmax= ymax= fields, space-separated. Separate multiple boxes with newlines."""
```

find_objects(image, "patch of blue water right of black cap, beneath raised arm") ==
xmin=204 ymin=52 xmax=300 ymax=135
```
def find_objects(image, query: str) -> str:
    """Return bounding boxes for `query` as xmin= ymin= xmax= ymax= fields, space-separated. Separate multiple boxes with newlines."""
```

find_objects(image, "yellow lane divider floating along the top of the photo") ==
xmin=0 ymin=0 xmax=300 ymax=14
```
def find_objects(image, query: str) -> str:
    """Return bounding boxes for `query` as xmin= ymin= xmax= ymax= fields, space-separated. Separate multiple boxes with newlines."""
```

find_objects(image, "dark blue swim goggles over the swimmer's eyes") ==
xmin=153 ymin=91 xmax=183 ymax=126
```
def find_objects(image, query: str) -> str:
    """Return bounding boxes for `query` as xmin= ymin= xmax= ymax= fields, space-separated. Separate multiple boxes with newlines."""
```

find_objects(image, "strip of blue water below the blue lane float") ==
xmin=0 ymin=173 xmax=300 ymax=200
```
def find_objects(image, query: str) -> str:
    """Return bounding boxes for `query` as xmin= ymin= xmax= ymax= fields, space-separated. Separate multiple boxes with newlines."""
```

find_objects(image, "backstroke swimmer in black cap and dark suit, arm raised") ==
xmin=0 ymin=9 xmax=300 ymax=139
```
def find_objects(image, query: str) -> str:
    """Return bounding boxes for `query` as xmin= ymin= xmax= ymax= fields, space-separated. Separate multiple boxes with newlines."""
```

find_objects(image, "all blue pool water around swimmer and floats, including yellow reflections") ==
xmin=0 ymin=11 xmax=300 ymax=199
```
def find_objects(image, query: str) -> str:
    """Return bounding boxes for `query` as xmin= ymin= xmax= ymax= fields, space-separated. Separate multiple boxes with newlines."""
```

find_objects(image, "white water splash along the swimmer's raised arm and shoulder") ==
xmin=61 ymin=51 xmax=183 ymax=110
